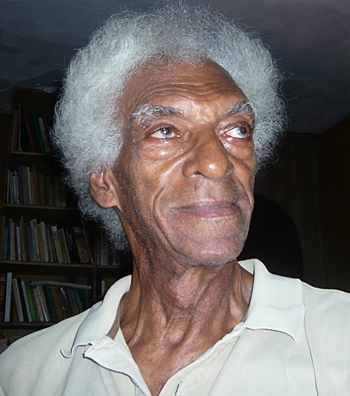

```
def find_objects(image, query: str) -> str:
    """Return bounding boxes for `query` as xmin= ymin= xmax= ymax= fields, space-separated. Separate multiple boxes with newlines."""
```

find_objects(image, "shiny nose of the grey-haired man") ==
xmin=183 ymin=128 xmax=233 ymax=180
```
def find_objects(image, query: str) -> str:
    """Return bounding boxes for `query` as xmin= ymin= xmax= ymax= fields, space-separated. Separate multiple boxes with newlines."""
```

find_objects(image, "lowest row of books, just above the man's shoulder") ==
xmin=0 ymin=272 xmax=91 ymax=323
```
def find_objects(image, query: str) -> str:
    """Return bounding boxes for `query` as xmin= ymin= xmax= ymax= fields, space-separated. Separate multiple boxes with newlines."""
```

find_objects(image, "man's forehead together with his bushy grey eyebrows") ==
xmin=122 ymin=61 xmax=253 ymax=120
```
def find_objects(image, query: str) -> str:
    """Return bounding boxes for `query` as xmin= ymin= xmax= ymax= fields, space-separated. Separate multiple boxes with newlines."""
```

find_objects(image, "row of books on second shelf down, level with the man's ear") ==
xmin=6 ymin=165 xmax=67 ymax=208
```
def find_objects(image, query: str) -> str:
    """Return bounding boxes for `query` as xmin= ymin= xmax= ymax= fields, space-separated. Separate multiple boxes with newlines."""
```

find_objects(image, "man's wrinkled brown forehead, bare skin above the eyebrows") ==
xmin=120 ymin=60 xmax=247 ymax=123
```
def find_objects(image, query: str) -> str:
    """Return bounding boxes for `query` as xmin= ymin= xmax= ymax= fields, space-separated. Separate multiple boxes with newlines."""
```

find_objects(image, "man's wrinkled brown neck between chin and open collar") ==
xmin=120 ymin=262 xmax=252 ymax=344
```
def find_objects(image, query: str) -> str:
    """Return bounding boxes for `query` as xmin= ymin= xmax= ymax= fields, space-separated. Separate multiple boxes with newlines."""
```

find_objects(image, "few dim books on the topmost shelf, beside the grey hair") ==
xmin=11 ymin=103 xmax=51 ymax=154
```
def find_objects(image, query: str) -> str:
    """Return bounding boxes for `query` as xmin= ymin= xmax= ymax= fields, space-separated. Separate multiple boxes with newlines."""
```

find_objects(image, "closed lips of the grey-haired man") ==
xmin=175 ymin=201 xmax=237 ymax=218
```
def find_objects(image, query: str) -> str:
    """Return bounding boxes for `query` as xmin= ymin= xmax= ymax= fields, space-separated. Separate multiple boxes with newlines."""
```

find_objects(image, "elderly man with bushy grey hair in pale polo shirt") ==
xmin=0 ymin=5 xmax=350 ymax=396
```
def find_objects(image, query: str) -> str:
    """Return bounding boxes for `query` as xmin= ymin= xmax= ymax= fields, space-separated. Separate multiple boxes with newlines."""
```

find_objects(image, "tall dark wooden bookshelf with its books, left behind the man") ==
xmin=0 ymin=88 xmax=131 ymax=341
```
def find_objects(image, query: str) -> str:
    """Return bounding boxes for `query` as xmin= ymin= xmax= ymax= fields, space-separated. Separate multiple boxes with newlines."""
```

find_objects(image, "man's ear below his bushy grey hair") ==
xmin=90 ymin=169 xmax=120 ymax=209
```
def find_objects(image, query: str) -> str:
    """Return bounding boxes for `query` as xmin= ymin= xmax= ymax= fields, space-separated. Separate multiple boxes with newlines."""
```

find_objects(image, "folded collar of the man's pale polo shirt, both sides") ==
xmin=61 ymin=259 xmax=305 ymax=357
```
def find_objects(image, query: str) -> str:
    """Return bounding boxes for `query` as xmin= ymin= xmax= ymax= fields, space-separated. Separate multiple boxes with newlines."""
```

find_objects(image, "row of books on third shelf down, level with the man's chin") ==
xmin=0 ymin=216 xmax=93 ymax=264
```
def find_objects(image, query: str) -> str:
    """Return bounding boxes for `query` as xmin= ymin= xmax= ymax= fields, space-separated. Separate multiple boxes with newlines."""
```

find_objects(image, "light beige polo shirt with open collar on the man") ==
xmin=0 ymin=260 xmax=350 ymax=396
